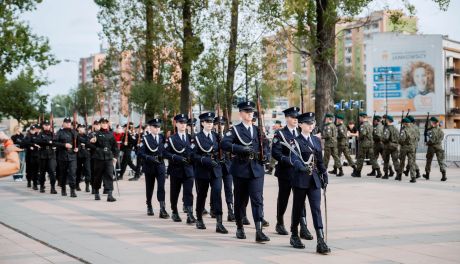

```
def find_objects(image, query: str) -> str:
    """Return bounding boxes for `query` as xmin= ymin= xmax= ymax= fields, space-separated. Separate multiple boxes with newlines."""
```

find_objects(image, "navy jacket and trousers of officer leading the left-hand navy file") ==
xmin=222 ymin=123 xmax=269 ymax=226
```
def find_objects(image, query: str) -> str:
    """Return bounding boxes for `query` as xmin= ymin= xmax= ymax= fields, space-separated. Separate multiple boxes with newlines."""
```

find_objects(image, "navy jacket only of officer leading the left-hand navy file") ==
xmin=221 ymin=123 xmax=270 ymax=178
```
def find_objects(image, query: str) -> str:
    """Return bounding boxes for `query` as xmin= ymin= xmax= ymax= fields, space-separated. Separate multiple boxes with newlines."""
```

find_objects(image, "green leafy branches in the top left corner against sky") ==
xmin=0 ymin=0 xmax=58 ymax=80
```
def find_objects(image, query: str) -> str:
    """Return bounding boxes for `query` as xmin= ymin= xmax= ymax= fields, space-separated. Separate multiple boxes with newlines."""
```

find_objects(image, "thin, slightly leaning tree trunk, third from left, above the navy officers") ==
xmin=225 ymin=0 xmax=239 ymax=118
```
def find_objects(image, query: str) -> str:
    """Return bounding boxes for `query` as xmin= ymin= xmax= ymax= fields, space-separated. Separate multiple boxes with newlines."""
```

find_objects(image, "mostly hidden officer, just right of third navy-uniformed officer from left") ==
xmin=211 ymin=116 xmax=235 ymax=222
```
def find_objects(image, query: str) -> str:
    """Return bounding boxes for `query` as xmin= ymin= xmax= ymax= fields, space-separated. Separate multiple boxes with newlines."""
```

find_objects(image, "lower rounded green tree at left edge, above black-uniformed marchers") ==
xmin=0 ymin=69 xmax=48 ymax=124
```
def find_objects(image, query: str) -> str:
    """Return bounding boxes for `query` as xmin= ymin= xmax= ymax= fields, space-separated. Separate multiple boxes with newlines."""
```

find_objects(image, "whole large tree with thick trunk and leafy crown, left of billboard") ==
xmin=259 ymin=0 xmax=450 ymax=122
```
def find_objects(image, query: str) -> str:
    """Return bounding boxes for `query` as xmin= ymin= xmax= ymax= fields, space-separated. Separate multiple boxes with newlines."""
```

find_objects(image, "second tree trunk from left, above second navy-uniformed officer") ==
xmin=180 ymin=0 xmax=193 ymax=113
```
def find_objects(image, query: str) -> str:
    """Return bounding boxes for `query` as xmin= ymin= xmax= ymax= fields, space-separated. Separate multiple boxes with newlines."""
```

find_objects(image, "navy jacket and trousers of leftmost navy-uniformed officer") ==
xmin=138 ymin=134 xmax=166 ymax=207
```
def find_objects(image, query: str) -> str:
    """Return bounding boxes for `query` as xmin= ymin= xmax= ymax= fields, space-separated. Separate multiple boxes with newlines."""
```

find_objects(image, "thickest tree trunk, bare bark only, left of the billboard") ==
xmin=313 ymin=0 xmax=337 ymax=125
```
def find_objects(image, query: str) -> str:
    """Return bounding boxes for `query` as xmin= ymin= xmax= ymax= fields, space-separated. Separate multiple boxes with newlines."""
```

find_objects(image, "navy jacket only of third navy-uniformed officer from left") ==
xmin=193 ymin=132 xmax=222 ymax=179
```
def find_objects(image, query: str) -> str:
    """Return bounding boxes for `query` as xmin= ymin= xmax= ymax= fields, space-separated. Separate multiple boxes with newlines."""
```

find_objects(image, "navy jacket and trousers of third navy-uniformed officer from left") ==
xmin=193 ymin=132 xmax=222 ymax=219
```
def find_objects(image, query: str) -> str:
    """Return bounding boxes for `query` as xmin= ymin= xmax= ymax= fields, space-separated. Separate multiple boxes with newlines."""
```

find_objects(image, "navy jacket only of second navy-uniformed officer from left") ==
xmin=164 ymin=133 xmax=194 ymax=178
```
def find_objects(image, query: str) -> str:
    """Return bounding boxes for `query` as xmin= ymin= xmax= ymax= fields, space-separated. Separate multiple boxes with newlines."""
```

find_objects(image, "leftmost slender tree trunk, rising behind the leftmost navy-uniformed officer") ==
xmin=144 ymin=0 xmax=154 ymax=83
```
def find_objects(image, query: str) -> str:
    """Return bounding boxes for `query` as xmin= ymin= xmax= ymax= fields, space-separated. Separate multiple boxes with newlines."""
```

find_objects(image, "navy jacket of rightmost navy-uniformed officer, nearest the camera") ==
xmin=291 ymin=134 xmax=328 ymax=189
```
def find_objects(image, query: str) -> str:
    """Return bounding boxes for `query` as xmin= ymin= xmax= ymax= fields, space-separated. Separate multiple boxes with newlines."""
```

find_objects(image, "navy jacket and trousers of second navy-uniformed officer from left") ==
xmin=164 ymin=133 xmax=194 ymax=213
